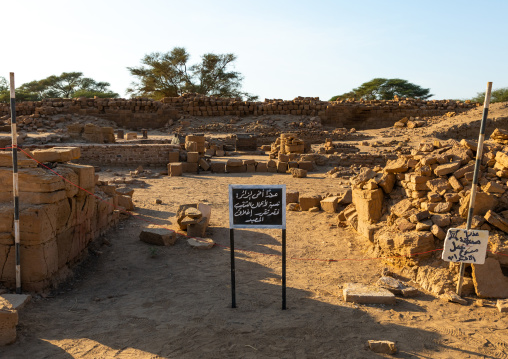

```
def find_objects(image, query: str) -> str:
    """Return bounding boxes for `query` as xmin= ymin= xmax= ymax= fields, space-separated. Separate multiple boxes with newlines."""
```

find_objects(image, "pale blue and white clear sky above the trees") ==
xmin=0 ymin=0 xmax=508 ymax=101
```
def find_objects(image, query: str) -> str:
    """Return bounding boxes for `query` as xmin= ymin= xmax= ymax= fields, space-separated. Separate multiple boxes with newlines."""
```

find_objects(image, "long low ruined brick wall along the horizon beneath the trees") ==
xmin=0 ymin=94 xmax=477 ymax=129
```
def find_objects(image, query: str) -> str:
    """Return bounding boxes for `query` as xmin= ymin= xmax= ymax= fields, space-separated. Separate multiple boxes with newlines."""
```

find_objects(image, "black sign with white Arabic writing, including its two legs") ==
xmin=229 ymin=185 xmax=286 ymax=310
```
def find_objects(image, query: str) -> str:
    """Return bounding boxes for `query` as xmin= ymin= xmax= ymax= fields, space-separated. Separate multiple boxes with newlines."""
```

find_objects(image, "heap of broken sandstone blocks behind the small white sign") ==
xmin=338 ymin=132 xmax=508 ymax=298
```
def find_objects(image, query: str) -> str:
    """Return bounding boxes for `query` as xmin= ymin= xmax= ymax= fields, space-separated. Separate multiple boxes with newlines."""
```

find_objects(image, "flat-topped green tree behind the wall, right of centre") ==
xmin=330 ymin=78 xmax=433 ymax=101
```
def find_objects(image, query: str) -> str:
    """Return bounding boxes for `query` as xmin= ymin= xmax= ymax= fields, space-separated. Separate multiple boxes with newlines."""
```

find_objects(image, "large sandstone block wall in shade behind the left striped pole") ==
xmin=0 ymin=151 xmax=119 ymax=292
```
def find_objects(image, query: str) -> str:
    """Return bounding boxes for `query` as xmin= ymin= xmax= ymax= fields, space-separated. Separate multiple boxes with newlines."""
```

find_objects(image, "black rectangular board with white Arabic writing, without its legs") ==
xmin=229 ymin=185 xmax=286 ymax=229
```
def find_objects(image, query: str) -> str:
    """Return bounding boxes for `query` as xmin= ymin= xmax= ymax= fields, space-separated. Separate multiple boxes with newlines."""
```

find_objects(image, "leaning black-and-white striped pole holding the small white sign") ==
xmin=457 ymin=82 xmax=492 ymax=296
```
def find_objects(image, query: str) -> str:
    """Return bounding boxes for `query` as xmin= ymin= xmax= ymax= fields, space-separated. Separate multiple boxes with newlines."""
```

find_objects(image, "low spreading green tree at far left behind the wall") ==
xmin=0 ymin=72 xmax=118 ymax=101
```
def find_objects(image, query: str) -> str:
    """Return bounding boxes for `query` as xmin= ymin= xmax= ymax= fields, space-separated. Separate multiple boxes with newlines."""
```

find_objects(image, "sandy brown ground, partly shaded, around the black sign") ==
xmin=0 ymin=169 xmax=508 ymax=358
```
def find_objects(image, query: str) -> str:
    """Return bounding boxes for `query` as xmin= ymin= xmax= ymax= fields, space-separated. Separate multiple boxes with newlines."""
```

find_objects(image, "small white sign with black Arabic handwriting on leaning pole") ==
xmin=441 ymin=228 xmax=489 ymax=264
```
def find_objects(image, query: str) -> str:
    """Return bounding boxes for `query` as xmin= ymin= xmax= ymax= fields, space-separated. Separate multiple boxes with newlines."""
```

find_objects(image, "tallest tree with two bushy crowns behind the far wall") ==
xmin=127 ymin=47 xmax=257 ymax=100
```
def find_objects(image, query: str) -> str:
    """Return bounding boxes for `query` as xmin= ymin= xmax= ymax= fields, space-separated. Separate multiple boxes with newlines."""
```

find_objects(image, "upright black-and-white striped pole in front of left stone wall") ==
xmin=10 ymin=72 xmax=21 ymax=294
